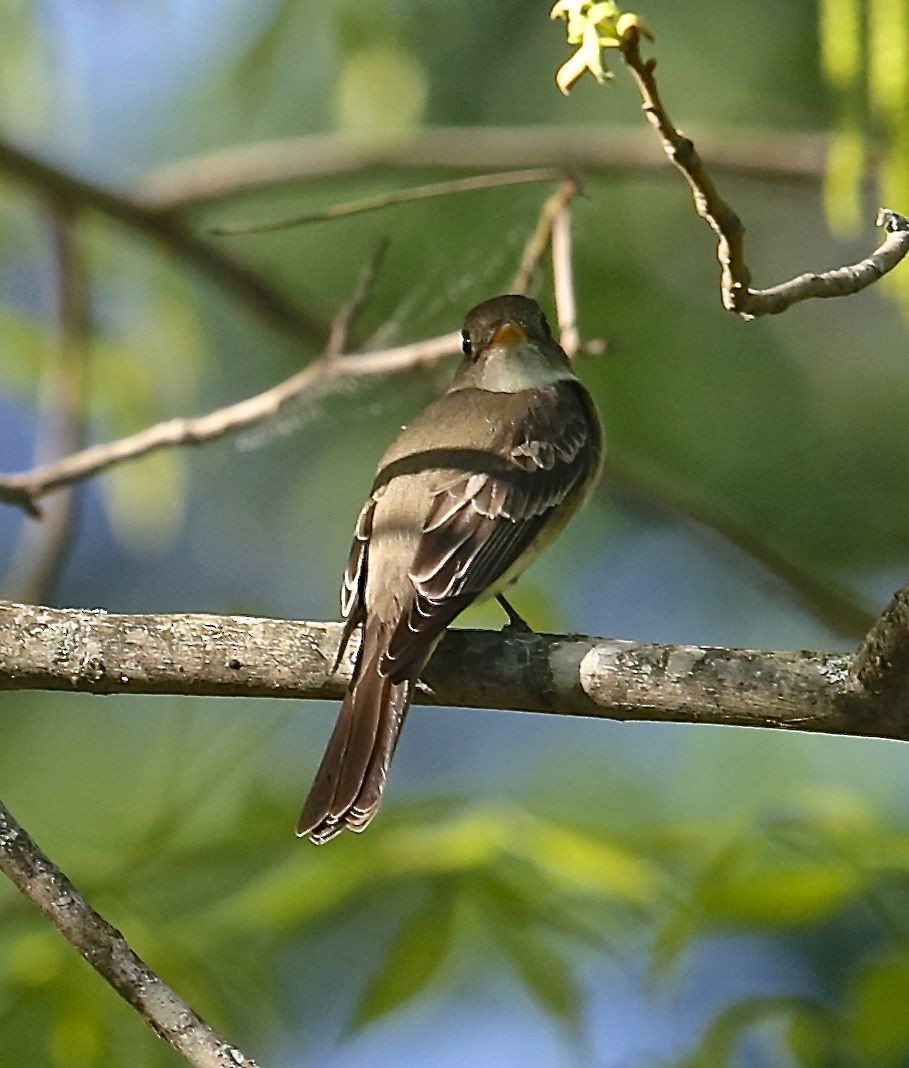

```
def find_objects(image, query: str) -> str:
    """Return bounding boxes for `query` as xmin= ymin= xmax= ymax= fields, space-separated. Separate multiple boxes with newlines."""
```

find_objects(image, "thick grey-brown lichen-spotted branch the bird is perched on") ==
xmin=0 ymin=602 xmax=909 ymax=740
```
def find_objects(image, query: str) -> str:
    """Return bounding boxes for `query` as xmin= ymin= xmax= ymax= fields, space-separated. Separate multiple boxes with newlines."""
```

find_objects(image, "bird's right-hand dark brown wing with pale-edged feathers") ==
xmin=380 ymin=381 xmax=600 ymax=682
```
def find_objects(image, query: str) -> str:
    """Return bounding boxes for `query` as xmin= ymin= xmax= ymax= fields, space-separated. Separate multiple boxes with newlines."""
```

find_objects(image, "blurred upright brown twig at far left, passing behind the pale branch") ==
xmin=5 ymin=203 xmax=90 ymax=603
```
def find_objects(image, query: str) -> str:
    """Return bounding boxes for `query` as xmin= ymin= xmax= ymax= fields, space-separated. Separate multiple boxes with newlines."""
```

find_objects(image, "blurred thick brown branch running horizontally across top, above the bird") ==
xmin=135 ymin=123 xmax=828 ymax=210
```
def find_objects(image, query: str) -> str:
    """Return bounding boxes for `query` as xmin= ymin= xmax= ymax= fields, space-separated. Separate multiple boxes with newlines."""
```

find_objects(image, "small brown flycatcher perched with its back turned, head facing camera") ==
xmin=297 ymin=294 xmax=605 ymax=845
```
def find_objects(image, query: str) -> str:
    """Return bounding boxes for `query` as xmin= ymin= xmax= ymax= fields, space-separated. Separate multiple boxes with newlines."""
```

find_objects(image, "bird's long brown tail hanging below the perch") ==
xmin=297 ymin=622 xmax=413 ymax=845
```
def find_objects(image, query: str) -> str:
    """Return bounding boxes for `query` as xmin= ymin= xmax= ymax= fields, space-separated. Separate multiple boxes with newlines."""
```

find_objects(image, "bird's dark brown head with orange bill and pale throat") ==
xmin=452 ymin=294 xmax=574 ymax=393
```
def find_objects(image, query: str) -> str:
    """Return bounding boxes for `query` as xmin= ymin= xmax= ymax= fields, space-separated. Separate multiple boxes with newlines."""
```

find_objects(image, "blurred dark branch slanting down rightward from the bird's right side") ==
xmin=604 ymin=457 xmax=876 ymax=639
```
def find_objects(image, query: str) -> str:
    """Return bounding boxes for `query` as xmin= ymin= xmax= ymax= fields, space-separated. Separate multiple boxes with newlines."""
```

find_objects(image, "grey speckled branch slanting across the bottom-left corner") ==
xmin=0 ymin=802 xmax=255 ymax=1068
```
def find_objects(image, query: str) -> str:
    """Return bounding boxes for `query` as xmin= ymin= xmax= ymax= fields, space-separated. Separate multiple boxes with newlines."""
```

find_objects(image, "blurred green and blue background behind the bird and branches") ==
xmin=0 ymin=0 xmax=909 ymax=1068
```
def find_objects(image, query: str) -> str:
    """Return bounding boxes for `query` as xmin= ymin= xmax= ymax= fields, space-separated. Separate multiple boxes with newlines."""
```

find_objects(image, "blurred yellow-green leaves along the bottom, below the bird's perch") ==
xmin=0 ymin=797 xmax=909 ymax=1068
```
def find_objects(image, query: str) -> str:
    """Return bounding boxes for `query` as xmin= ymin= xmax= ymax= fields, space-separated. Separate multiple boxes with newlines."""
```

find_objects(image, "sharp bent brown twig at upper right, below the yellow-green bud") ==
xmin=621 ymin=28 xmax=909 ymax=319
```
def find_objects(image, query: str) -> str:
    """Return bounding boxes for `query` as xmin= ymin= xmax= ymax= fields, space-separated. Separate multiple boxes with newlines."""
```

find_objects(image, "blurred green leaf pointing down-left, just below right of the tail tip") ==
xmin=350 ymin=888 xmax=457 ymax=1031
